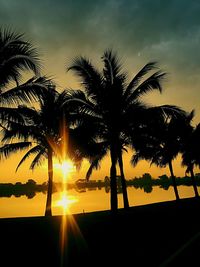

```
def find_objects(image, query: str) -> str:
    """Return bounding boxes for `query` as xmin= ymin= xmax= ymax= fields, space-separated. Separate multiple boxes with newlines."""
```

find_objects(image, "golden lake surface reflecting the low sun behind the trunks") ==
xmin=0 ymin=186 xmax=198 ymax=218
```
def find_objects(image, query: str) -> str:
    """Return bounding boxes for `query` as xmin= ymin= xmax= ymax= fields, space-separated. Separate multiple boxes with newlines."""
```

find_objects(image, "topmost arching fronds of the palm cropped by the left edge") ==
xmin=0 ymin=28 xmax=41 ymax=86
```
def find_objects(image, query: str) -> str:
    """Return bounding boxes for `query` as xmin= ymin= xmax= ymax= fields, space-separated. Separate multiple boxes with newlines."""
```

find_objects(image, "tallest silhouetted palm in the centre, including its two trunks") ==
xmin=69 ymin=51 xmax=181 ymax=212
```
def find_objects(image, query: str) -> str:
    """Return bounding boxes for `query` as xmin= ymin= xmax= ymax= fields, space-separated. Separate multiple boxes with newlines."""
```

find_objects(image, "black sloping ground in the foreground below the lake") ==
xmin=0 ymin=199 xmax=200 ymax=267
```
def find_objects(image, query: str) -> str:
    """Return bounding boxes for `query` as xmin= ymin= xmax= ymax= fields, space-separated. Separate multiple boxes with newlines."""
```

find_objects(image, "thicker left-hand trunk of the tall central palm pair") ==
xmin=110 ymin=145 xmax=118 ymax=214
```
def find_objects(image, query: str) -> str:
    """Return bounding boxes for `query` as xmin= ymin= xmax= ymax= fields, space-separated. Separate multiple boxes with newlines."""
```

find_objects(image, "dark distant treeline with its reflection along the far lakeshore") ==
xmin=0 ymin=173 xmax=200 ymax=199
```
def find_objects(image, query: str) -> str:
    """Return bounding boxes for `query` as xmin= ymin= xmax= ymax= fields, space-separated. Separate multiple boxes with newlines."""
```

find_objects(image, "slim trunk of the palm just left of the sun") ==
xmin=45 ymin=148 xmax=53 ymax=216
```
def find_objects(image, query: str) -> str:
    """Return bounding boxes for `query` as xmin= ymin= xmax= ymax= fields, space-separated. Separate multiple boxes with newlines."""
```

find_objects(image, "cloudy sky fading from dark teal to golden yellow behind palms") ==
xmin=0 ymin=0 xmax=200 ymax=182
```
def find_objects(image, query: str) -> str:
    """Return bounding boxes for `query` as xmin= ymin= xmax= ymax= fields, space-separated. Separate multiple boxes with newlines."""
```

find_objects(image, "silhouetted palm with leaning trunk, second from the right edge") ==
xmin=131 ymin=111 xmax=189 ymax=200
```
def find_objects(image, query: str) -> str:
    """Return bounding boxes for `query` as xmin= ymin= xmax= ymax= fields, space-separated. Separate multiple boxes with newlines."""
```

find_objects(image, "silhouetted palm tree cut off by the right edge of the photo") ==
xmin=181 ymin=114 xmax=200 ymax=198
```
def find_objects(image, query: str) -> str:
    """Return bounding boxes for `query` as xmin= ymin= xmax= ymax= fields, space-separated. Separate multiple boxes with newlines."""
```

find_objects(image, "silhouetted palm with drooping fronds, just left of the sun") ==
xmin=0 ymin=84 xmax=71 ymax=216
